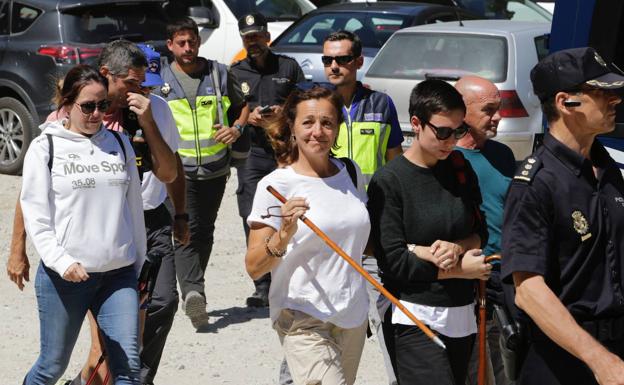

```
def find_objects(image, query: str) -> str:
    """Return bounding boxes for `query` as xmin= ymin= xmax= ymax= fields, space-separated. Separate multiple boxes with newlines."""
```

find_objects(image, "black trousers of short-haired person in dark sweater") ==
xmin=383 ymin=308 xmax=476 ymax=385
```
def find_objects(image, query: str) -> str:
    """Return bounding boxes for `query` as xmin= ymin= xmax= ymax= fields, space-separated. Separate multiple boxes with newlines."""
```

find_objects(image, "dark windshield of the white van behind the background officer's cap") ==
xmin=225 ymin=0 xmax=314 ymax=21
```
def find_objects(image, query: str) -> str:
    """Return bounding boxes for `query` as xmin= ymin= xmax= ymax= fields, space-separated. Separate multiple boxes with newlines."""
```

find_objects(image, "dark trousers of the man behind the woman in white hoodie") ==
xmin=140 ymin=204 xmax=179 ymax=384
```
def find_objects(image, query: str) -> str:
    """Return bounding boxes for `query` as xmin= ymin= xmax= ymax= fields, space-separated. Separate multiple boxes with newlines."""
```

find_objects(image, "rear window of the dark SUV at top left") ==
xmin=62 ymin=3 xmax=167 ymax=44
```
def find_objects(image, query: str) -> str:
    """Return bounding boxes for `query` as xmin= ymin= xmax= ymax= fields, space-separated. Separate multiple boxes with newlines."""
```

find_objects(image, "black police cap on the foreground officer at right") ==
xmin=531 ymin=47 xmax=624 ymax=101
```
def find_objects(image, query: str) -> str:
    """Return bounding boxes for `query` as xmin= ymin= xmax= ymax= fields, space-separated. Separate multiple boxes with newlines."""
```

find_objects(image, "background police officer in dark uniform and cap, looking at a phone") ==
xmin=231 ymin=13 xmax=305 ymax=307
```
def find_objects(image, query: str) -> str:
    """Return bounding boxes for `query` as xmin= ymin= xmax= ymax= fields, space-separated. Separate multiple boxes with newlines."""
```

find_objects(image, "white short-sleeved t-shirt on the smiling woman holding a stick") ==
xmin=247 ymin=159 xmax=370 ymax=328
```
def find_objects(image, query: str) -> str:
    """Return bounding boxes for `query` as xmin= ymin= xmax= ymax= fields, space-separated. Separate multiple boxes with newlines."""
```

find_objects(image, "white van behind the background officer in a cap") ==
xmin=172 ymin=0 xmax=316 ymax=64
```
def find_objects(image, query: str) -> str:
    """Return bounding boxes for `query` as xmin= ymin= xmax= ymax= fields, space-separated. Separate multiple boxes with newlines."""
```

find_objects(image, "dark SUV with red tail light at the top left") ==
xmin=0 ymin=0 xmax=166 ymax=174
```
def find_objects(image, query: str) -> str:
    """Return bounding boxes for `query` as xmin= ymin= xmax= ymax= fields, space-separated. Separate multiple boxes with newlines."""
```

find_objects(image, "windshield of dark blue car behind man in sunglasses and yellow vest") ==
xmin=274 ymin=12 xmax=410 ymax=48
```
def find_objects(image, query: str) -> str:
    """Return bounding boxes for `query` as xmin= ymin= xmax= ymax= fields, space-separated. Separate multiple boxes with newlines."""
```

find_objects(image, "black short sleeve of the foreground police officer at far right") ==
xmin=501 ymin=179 xmax=552 ymax=283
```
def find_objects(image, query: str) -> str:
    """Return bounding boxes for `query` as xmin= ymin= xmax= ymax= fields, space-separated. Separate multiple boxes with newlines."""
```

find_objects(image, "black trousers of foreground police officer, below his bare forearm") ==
xmin=517 ymin=336 xmax=624 ymax=385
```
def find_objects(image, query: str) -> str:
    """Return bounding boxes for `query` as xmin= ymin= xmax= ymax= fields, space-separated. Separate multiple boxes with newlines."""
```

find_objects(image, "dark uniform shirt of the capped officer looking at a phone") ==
xmin=231 ymin=51 xmax=305 ymax=153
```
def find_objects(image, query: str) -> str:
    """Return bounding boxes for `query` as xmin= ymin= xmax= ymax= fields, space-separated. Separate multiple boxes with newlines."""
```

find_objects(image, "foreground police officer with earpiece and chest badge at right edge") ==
xmin=502 ymin=48 xmax=624 ymax=385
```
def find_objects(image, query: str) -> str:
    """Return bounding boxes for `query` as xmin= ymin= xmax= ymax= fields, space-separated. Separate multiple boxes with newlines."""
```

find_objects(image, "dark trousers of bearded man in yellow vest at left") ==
xmin=175 ymin=175 xmax=228 ymax=299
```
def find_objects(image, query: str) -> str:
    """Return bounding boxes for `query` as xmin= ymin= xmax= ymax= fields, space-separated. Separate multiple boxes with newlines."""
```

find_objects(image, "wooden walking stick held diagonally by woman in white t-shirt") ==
xmin=267 ymin=186 xmax=446 ymax=349
